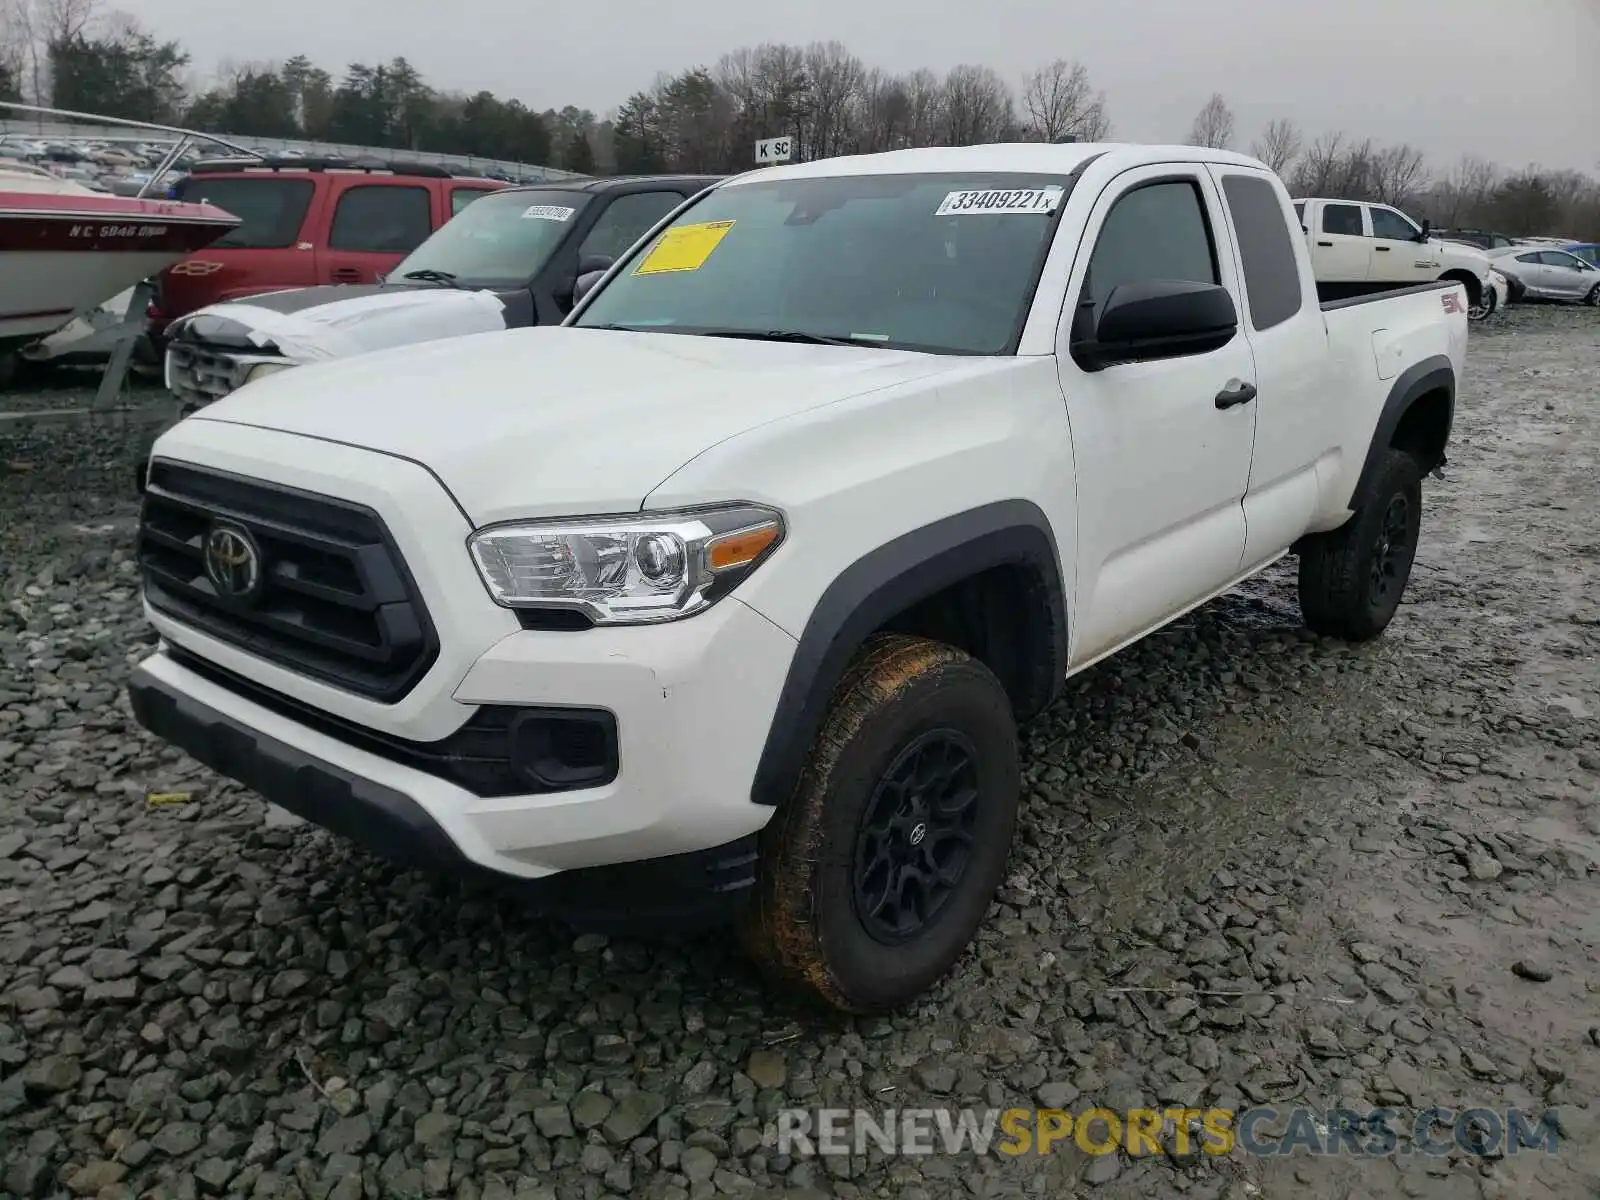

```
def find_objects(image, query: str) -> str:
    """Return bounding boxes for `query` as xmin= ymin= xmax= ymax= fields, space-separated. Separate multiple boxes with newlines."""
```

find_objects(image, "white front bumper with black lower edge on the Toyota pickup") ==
xmin=128 ymin=597 xmax=794 ymax=880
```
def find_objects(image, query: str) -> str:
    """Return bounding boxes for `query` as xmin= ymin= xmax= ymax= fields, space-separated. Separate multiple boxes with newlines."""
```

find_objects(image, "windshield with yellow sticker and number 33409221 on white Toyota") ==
xmin=576 ymin=173 xmax=1067 ymax=354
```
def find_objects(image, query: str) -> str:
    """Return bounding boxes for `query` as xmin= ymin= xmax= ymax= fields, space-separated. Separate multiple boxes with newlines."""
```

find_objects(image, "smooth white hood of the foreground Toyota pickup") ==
xmin=187 ymin=326 xmax=970 ymax=525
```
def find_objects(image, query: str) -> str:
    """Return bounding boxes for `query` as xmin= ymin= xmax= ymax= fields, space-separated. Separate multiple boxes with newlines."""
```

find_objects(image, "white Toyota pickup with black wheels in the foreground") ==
xmin=130 ymin=144 xmax=1467 ymax=1011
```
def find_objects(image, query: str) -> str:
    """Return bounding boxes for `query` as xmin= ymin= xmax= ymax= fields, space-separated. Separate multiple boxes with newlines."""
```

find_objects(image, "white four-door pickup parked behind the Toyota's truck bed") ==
xmin=1294 ymin=198 xmax=1493 ymax=320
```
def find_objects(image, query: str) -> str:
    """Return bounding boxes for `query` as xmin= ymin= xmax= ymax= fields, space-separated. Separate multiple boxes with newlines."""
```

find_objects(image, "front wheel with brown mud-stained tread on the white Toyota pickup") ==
xmin=741 ymin=635 xmax=1021 ymax=1013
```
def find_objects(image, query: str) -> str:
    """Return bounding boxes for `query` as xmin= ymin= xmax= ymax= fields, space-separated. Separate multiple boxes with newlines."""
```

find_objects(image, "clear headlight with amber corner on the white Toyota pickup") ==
xmin=467 ymin=504 xmax=784 ymax=626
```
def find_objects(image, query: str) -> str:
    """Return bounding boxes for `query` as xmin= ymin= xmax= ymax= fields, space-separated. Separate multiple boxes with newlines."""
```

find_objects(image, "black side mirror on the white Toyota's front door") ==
xmin=1072 ymin=278 xmax=1238 ymax=371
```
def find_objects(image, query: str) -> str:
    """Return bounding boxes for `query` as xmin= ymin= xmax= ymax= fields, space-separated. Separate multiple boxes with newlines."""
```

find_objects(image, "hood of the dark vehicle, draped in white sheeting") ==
xmin=173 ymin=285 xmax=506 ymax=363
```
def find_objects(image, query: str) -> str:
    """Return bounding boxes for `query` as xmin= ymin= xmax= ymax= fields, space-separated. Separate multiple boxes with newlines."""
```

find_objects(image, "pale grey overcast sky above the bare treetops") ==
xmin=112 ymin=0 xmax=1600 ymax=170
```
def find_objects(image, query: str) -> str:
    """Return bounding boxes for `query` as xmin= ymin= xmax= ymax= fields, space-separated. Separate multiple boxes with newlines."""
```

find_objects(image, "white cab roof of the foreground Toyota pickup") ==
xmin=728 ymin=142 xmax=1266 ymax=186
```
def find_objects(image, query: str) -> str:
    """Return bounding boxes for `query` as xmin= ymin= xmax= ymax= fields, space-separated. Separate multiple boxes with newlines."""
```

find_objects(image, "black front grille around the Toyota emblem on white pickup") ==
xmin=139 ymin=459 xmax=438 ymax=704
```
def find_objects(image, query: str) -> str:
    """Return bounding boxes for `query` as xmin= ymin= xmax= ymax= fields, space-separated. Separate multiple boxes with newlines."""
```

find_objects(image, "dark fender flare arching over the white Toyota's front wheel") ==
xmin=750 ymin=499 xmax=1067 ymax=806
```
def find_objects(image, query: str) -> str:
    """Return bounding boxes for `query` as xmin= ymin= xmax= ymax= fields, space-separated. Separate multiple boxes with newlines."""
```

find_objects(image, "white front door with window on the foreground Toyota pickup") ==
xmin=1058 ymin=165 xmax=1256 ymax=664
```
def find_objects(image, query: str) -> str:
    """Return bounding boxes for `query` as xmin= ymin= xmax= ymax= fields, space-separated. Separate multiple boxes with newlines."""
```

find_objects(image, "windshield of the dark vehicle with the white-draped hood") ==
xmin=389 ymin=189 xmax=589 ymax=286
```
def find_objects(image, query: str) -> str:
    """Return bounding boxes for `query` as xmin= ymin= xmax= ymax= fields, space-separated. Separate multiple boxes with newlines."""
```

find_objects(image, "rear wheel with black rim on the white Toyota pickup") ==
xmin=1299 ymin=450 xmax=1422 ymax=642
